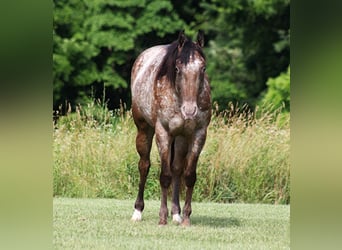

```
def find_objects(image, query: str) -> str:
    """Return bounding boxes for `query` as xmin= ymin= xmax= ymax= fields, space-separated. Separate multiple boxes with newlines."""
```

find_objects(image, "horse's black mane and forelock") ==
xmin=157 ymin=39 xmax=205 ymax=85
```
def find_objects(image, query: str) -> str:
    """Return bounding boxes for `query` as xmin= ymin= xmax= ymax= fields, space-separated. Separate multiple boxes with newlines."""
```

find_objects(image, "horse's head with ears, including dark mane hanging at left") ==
xmin=157 ymin=31 xmax=207 ymax=120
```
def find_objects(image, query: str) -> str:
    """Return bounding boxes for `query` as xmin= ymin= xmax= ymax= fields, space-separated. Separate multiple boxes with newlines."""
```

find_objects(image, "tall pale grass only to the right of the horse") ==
xmin=195 ymin=105 xmax=290 ymax=204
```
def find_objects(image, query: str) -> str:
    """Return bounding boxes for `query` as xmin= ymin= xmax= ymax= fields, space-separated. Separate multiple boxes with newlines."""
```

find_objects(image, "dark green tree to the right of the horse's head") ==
xmin=196 ymin=0 xmax=290 ymax=108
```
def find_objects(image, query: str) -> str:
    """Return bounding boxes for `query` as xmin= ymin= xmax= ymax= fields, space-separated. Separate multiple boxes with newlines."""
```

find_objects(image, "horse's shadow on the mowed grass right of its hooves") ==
xmin=191 ymin=216 xmax=240 ymax=227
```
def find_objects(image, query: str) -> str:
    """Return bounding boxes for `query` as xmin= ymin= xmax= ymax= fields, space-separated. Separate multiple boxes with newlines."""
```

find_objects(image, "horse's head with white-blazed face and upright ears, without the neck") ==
xmin=174 ymin=31 xmax=206 ymax=120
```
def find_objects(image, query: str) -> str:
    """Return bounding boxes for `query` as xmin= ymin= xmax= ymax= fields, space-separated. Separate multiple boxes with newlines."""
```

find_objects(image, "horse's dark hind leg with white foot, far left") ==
xmin=132 ymin=121 xmax=154 ymax=221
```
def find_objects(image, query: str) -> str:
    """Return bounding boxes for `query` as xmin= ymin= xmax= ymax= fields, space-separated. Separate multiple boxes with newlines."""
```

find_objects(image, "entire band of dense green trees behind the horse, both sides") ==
xmin=53 ymin=0 xmax=290 ymax=110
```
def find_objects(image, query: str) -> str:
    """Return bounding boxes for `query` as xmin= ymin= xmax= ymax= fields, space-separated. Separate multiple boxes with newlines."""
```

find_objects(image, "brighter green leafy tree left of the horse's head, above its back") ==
xmin=53 ymin=0 xmax=184 ymax=111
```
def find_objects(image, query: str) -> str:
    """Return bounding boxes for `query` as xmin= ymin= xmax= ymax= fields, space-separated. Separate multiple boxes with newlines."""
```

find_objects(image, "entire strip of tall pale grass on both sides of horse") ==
xmin=53 ymin=102 xmax=290 ymax=204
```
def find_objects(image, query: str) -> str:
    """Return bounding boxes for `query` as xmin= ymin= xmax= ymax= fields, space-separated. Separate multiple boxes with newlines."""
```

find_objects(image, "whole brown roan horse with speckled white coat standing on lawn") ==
xmin=131 ymin=30 xmax=211 ymax=226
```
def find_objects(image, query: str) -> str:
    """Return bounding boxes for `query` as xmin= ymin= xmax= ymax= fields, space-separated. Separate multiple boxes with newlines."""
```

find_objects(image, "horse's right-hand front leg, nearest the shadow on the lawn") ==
xmin=182 ymin=129 xmax=207 ymax=226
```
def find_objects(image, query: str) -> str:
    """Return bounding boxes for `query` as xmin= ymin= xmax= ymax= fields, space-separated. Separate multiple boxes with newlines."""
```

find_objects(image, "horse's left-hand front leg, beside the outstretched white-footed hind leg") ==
xmin=156 ymin=121 xmax=172 ymax=225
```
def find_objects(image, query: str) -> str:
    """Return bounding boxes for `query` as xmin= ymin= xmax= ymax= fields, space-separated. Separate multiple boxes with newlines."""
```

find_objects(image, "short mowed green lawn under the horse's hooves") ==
xmin=53 ymin=198 xmax=290 ymax=250
